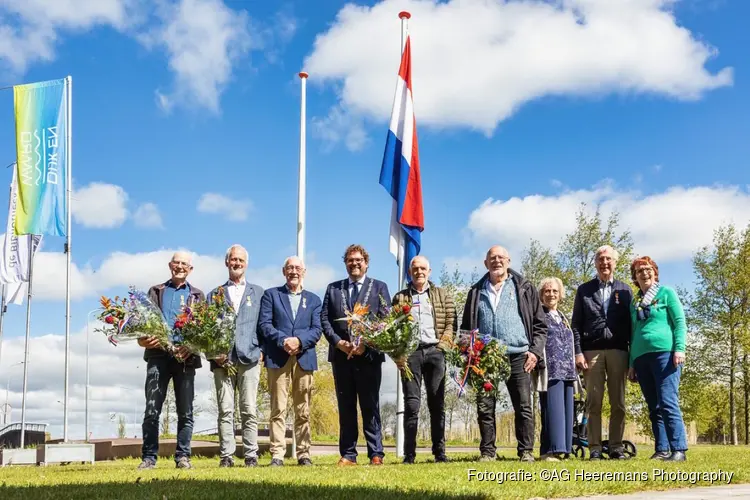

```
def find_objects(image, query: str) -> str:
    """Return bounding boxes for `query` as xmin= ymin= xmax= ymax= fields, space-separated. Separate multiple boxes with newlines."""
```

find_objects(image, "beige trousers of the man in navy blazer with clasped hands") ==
xmin=268 ymin=356 xmax=313 ymax=460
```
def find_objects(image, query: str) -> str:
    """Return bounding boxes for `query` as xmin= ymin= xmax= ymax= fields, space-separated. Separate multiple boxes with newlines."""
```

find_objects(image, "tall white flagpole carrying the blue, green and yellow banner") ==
xmin=63 ymin=76 xmax=73 ymax=443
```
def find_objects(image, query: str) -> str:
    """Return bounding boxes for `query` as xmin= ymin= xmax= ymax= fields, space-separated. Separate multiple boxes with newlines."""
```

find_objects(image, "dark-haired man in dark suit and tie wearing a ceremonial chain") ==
xmin=321 ymin=245 xmax=391 ymax=465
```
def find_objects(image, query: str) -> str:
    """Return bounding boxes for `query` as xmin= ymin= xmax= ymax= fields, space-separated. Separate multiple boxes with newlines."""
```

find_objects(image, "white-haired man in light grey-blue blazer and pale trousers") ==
xmin=208 ymin=245 xmax=263 ymax=467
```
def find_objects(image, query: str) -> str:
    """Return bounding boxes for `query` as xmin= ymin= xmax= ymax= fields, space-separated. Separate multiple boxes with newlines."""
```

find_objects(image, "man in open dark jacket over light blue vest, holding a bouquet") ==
xmin=461 ymin=245 xmax=547 ymax=462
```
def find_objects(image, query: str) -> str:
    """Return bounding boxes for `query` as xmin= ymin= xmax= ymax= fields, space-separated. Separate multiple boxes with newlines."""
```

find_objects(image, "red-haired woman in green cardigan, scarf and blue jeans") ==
xmin=628 ymin=257 xmax=687 ymax=462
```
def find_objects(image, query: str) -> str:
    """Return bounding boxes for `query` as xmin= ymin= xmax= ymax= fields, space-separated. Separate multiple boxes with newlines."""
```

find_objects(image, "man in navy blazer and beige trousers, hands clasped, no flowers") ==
xmin=259 ymin=257 xmax=323 ymax=466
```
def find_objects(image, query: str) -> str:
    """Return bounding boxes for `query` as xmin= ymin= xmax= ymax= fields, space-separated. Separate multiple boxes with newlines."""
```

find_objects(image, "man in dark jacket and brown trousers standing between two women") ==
xmin=571 ymin=245 xmax=633 ymax=460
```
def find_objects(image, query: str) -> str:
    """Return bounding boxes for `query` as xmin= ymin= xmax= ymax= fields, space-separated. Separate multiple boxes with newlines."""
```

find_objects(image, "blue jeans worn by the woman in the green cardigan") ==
xmin=633 ymin=352 xmax=687 ymax=452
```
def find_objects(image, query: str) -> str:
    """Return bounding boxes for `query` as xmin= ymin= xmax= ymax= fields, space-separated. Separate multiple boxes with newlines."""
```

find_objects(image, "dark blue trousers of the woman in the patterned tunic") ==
xmin=539 ymin=380 xmax=575 ymax=455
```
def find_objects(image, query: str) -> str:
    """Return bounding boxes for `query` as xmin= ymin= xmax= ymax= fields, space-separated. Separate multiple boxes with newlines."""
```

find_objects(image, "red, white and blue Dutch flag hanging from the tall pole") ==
xmin=380 ymin=37 xmax=424 ymax=286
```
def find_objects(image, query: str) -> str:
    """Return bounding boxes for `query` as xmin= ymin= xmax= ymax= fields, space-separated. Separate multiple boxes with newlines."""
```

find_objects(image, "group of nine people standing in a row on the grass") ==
xmin=134 ymin=245 xmax=687 ymax=469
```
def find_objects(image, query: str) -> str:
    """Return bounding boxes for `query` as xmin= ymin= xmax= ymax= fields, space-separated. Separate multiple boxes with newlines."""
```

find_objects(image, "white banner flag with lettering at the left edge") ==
xmin=0 ymin=168 xmax=42 ymax=305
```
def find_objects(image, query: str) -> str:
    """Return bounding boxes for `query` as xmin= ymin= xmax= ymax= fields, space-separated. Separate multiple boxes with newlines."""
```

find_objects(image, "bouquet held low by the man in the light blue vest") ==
xmin=446 ymin=330 xmax=510 ymax=396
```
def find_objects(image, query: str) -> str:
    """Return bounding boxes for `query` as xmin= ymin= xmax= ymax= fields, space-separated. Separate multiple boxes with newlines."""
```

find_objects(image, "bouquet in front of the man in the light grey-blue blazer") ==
xmin=174 ymin=288 xmax=237 ymax=375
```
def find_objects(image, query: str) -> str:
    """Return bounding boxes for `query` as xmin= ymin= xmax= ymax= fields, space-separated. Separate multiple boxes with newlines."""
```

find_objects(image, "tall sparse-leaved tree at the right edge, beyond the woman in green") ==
xmin=689 ymin=225 xmax=750 ymax=445
